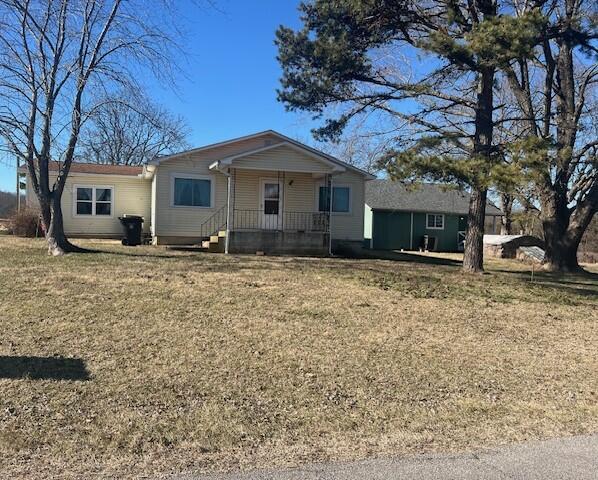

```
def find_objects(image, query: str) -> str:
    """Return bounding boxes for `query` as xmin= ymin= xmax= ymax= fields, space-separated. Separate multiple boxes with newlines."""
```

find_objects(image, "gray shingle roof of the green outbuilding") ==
xmin=365 ymin=180 xmax=501 ymax=215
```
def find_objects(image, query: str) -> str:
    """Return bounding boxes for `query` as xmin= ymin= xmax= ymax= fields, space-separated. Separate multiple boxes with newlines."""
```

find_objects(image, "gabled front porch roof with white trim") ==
xmin=209 ymin=142 xmax=347 ymax=175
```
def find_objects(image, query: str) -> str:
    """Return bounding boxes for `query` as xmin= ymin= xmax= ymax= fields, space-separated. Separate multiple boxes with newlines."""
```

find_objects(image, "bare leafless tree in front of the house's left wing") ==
xmin=0 ymin=0 xmax=183 ymax=255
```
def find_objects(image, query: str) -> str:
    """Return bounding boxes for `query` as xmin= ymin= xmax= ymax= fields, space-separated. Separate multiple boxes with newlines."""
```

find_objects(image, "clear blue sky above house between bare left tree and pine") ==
xmin=0 ymin=0 xmax=313 ymax=190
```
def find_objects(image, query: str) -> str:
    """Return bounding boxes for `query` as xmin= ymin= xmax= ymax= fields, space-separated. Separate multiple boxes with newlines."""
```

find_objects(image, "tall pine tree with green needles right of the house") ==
xmin=276 ymin=0 xmax=542 ymax=272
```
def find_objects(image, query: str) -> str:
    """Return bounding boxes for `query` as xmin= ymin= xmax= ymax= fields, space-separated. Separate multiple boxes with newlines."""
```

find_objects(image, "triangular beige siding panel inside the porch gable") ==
xmin=233 ymin=145 xmax=330 ymax=173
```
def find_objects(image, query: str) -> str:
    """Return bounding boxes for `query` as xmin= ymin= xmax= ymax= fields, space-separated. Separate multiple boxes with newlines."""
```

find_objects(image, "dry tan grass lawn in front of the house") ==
xmin=0 ymin=236 xmax=598 ymax=478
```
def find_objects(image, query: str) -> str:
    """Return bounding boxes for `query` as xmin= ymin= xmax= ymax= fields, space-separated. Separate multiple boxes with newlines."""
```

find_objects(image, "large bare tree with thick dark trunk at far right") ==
xmin=504 ymin=0 xmax=598 ymax=271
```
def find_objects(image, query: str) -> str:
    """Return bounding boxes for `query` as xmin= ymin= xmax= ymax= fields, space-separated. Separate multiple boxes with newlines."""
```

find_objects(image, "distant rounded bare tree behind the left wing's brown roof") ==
xmin=77 ymin=94 xmax=189 ymax=165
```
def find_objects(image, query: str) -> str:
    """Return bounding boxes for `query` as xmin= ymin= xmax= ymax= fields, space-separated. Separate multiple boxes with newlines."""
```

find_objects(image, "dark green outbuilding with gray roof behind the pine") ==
xmin=364 ymin=180 xmax=502 ymax=252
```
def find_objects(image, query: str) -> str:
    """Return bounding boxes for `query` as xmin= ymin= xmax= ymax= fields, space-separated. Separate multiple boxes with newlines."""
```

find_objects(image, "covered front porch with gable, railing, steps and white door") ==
xmin=202 ymin=141 xmax=348 ymax=255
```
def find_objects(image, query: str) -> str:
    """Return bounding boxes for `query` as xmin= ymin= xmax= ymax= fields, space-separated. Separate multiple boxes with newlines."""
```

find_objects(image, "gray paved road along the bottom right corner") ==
xmin=167 ymin=434 xmax=598 ymax=480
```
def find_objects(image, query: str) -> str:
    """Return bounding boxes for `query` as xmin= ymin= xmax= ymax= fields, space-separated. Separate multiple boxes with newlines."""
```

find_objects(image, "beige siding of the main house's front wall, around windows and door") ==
xmin=154 ymin=135 xmax=364 ymax=241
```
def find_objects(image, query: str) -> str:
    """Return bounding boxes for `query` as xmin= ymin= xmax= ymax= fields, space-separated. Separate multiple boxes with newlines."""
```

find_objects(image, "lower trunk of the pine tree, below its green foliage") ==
xmin=463 ymin=189 xmax=487 ymax=273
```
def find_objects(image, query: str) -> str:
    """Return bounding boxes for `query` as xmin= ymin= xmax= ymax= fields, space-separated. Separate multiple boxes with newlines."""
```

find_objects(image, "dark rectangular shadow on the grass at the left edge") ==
xmin=0 ymin=355 xmax=90 ymax=381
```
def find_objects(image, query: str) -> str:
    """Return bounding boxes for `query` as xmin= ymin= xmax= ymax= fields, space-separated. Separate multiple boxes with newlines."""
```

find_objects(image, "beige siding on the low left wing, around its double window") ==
xmin=27 ymin=173 xmax=151 ymax=237
